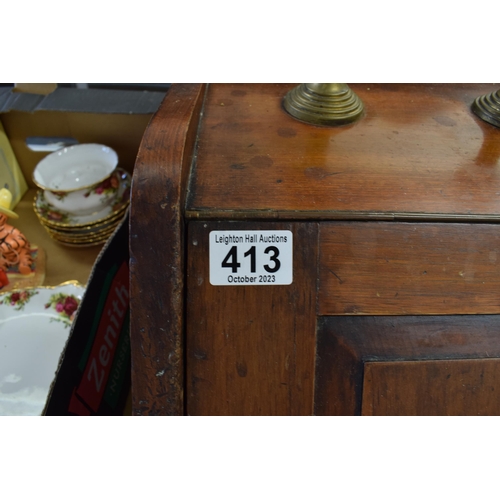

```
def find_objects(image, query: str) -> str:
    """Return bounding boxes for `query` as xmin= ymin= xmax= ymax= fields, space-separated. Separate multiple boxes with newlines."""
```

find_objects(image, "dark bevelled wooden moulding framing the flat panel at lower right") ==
xmin=314 ymin=315 xmax=500 ymax=415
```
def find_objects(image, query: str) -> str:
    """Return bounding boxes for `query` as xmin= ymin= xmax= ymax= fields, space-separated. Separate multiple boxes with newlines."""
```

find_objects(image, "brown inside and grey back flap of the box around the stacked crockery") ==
xmin=4 ymin=85 xmax=166 ymax=286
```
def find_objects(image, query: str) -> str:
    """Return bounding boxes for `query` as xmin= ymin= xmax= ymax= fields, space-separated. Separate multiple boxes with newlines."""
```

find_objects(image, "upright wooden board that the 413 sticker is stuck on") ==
xmin=186 ymin=222 xmax=317 ymax=415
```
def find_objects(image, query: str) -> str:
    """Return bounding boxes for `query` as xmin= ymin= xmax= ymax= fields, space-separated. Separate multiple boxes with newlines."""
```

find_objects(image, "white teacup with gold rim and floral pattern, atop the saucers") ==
xmin=33 ymin=144 xmax=120 ymax=215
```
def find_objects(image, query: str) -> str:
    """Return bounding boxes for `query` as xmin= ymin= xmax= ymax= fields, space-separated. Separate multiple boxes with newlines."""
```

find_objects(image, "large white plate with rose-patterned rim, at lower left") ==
xmin=0 ymin=281 xmax=85 ymax=415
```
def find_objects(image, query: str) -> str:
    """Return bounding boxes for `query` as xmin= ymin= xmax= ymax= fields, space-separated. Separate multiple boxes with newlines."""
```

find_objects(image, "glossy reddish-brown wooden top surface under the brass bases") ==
xmin=187 ymin=84 xmax=500 ymax=220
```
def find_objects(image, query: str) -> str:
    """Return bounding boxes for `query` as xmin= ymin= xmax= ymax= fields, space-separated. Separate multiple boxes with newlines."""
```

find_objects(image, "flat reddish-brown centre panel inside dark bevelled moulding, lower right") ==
xmin=362 ymin=359 xmax=500 ymax=415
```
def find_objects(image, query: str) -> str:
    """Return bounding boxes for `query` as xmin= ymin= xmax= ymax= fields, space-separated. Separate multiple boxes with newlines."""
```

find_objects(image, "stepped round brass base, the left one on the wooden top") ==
xmin=283 ymin=83 xmax=364 ymax=125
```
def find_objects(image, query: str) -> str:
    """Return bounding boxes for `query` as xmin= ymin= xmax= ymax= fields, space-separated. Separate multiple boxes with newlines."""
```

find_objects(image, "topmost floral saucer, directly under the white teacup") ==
xmin=33 ymin=168 xmax=132 ymax=228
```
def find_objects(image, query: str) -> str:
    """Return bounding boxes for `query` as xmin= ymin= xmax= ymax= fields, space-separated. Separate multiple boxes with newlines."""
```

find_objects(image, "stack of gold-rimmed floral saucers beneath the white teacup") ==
xmin=33 ymin=168 xmax=131 ymax=247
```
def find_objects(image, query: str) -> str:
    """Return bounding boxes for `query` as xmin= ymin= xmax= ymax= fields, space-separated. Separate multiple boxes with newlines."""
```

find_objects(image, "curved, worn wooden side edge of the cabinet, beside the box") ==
xmin=130 ymin=84 xmax=206 ymax=415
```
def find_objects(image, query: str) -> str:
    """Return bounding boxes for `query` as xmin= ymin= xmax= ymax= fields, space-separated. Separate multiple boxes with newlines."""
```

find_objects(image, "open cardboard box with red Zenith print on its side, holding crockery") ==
xmin=0 ymin=87 xmax=165 ymax=415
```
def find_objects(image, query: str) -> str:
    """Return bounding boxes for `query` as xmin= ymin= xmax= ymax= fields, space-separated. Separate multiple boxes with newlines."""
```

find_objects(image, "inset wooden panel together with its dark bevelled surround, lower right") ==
xmin=315 ymin=315 xmax=500 ymax=415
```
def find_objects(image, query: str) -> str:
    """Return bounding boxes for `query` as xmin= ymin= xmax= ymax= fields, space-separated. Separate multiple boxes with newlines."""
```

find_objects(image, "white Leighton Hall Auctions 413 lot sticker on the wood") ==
xmin=209 ymin=231 xmax=293 ymax=285
